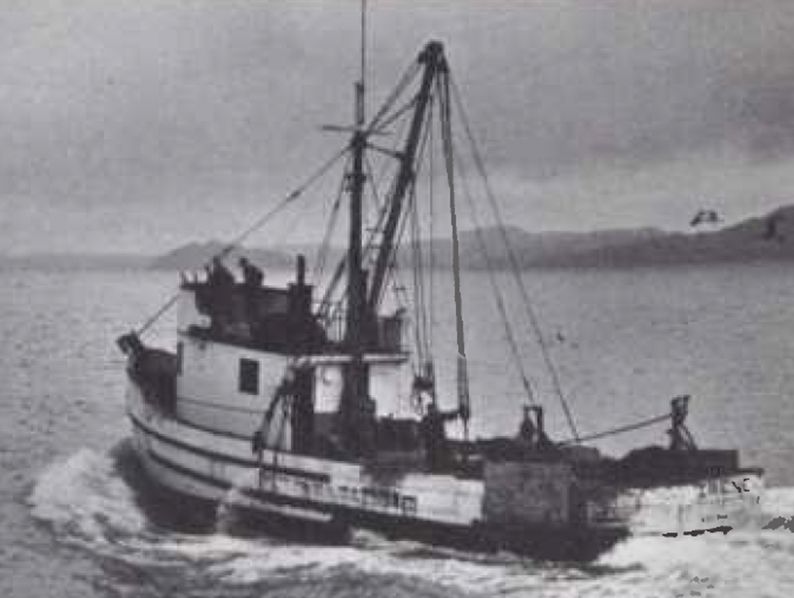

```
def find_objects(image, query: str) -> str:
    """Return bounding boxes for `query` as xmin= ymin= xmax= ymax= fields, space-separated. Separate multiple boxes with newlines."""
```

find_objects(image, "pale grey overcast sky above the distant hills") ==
xmin=0 ymin=0 xmax=794 ymax=254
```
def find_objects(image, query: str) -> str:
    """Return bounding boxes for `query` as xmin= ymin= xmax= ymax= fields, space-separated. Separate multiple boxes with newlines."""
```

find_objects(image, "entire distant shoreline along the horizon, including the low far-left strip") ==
xmin=6 ymin=205 xmax=794 ymax=272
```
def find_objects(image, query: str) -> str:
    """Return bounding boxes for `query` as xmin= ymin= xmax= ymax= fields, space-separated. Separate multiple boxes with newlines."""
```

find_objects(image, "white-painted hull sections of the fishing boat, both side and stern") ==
xmin=127 ymin=383 xmax=762 ymax=560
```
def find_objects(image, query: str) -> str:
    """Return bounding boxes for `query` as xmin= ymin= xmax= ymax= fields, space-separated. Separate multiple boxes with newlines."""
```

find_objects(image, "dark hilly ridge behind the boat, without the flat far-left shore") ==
xmin=151 ymin=206 xmax=794 ymax=270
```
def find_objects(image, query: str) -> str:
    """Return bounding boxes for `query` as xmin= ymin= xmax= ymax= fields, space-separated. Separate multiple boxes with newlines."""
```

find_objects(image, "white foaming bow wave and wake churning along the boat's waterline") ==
xmin=28 ymin=446 xmax=794 ymax=597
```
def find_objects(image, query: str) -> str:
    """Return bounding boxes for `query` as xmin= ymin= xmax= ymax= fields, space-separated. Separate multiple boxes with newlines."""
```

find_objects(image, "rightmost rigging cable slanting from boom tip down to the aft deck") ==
xmin=449 ymin=76 xmax=579 ymax=442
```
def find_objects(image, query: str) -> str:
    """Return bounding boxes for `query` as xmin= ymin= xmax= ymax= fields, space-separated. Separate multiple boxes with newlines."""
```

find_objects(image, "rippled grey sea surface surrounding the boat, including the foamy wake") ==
xmin=0 ymin=264 xmax=794 ymax=598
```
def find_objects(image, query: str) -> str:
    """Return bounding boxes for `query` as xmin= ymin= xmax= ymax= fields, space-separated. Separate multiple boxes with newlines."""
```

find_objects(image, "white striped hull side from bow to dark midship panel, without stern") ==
xmin=128 ymin=384 xmax=483 ymax=527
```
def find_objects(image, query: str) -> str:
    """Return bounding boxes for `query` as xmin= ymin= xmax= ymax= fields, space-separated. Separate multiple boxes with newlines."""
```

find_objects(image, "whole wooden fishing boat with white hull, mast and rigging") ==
xmin=118 ymin=32 xmax=762 ymax=560
